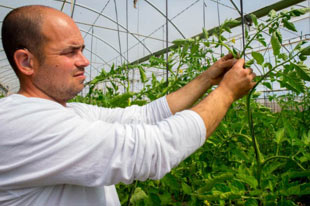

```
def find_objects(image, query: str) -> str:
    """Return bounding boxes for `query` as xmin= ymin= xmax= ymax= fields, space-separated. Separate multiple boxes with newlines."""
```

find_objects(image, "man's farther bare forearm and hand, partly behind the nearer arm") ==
xmin=166 ymin=54 xmax=237 ymax=114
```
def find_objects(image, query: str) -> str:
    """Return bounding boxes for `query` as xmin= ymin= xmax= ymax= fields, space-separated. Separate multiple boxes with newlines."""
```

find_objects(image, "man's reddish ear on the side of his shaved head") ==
xmin=14 ymin=49 xmax=34 ymax=76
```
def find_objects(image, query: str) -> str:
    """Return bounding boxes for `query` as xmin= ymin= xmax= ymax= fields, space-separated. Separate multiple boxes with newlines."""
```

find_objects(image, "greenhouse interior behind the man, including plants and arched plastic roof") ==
xmin=0 ymin=0 xmax=310 ymax=206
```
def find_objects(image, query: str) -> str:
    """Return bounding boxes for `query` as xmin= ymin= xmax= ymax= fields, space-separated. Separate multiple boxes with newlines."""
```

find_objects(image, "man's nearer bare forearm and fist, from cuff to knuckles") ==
xmin=191 ymin=59 xmax=255 ymax=138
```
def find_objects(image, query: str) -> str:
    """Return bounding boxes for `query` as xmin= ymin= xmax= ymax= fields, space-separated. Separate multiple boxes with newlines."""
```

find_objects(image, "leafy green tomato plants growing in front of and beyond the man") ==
xmin=74 ymin=9 xmax=310 ymax=206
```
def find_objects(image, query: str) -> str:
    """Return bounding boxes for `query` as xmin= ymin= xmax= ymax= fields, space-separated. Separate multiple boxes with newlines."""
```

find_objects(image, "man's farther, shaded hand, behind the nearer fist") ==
xmin=204 ymin=54 xmax=237 ymax=85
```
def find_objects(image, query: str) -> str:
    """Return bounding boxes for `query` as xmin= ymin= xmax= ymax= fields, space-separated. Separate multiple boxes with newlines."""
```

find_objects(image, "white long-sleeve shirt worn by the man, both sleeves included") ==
xmin=0 ymin=94 xmax=206 ymax=206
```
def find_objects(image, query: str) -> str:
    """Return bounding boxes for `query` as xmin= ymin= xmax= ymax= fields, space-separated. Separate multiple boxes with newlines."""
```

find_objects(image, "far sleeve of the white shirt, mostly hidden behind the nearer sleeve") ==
xmin=68 ymin=96 xmax=172 ymax=124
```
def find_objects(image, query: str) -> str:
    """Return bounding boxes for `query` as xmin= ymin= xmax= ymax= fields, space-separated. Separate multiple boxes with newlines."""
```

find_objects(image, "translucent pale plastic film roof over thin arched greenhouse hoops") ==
xmin=0 ymin=0 xmax=310 ymax=94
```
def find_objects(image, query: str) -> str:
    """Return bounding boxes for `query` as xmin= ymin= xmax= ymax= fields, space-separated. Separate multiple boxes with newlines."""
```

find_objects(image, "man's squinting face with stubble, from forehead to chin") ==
xmin=32 ymin=13 xmax=89 ymax=103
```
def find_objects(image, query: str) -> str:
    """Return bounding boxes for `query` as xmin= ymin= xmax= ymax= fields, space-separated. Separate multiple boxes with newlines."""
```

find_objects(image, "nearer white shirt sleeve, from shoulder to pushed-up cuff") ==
xmin=0 ymin=100 xmax=206 ymax=188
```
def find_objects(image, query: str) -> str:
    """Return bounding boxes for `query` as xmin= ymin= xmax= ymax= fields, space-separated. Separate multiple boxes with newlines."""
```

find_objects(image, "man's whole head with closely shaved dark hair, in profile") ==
xmin=2 ymin=6 xmax=89 ymax=104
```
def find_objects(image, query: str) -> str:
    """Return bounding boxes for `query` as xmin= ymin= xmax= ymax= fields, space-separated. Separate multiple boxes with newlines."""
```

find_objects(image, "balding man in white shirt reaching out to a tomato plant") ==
xmin=0 ymin=6 xmax=255 ymax=206
